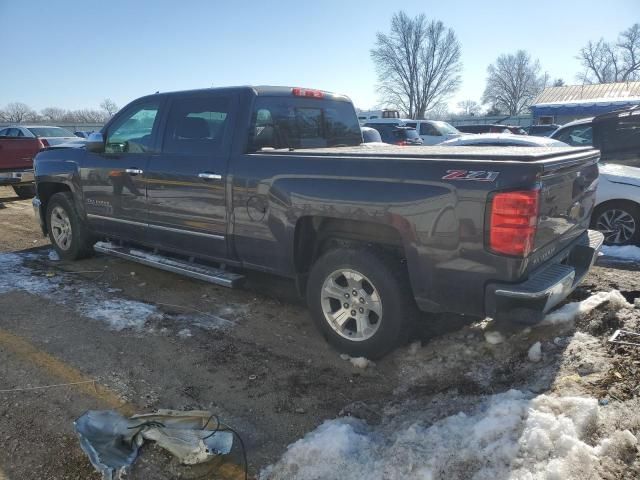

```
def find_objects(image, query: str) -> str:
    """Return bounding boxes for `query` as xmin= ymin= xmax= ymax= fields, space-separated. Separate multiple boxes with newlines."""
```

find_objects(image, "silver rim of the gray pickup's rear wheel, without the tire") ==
xmin=321 ymin=268 xmax=382 ymax=342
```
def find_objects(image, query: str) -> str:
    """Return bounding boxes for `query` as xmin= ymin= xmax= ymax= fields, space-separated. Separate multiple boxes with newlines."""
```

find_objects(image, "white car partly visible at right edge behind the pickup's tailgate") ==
xmin=591 ymin=163 xmax=640 ymax=245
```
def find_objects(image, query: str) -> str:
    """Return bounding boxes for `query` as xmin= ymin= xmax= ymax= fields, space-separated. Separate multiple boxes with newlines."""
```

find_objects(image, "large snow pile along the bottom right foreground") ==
xmin=259 ymin=390 xmax=637 ymax=480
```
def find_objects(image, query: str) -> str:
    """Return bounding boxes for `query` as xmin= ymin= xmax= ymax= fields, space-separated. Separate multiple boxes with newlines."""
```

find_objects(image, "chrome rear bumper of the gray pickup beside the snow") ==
xmin=485 ymin=230 xmax=604 ymax=323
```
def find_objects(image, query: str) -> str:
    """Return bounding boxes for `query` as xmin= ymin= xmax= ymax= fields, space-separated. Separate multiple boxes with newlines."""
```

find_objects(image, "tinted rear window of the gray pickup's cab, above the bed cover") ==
xmin=249 ymin=96 xmax=362 ymax=151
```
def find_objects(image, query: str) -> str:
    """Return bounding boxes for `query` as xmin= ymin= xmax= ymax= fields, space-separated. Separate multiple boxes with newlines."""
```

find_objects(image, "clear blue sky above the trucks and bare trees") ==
xmin=0 ymin=0 xmax=640 ymax=113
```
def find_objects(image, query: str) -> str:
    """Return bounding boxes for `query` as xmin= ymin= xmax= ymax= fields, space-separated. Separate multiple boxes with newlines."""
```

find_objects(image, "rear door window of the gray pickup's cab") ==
xmin=162 ymin=96 xmax=231 ymax=155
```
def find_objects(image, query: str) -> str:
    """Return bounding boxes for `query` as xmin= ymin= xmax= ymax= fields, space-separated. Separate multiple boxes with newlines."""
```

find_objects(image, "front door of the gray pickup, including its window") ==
xmin=80 ymin=99 xmax=161 ymax=241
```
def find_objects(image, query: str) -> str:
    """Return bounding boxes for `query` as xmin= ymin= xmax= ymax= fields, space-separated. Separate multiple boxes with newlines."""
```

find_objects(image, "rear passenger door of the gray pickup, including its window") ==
xmin=146 ymin=93 xmax=237 ymax=259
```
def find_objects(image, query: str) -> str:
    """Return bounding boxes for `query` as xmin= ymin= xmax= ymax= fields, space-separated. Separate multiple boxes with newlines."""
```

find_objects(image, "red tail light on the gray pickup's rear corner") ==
xmin=489 ymin=190 xmax=540 ymax=257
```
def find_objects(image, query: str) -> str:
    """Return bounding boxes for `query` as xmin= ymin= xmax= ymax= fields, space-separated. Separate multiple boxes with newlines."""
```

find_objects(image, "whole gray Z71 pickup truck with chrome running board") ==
xmin=34 ymin=87 xmax=602 ymax=358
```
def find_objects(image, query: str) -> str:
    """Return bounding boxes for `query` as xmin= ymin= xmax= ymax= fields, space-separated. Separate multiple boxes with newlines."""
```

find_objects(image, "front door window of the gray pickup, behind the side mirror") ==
xmin=105 ymin=101 xmax=160 ymax=153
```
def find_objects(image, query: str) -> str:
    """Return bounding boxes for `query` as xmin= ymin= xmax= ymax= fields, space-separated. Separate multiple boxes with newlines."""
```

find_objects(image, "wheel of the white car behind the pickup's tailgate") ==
xmin=591 ymin=200 xmax=640 ymax=245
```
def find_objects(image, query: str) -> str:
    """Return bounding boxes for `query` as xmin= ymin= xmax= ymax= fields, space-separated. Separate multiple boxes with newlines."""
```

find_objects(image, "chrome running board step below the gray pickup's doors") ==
xmin=93 ymin=242 xmax=244 ymax=288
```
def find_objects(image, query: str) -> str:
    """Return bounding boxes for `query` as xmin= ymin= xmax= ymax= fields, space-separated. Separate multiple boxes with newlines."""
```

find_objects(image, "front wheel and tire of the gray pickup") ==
xmin=47 ymin=192 xmax=93 ymax=260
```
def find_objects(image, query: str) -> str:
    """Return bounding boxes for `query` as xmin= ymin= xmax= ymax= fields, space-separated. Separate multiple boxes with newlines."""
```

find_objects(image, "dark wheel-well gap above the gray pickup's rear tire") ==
xmin=294 ymin=216 xmax=404 ymax=275
